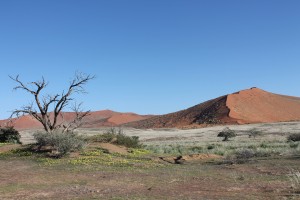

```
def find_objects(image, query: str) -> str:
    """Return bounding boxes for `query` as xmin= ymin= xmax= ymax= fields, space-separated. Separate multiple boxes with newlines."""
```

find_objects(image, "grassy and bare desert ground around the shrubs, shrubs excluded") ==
xmin=0 ymin=122 xmax=300 ymax=199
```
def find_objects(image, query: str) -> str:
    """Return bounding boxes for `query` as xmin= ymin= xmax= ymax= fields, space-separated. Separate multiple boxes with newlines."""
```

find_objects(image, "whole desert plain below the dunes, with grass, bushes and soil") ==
xmin=0 ymin=122 xmax=300 ymax=199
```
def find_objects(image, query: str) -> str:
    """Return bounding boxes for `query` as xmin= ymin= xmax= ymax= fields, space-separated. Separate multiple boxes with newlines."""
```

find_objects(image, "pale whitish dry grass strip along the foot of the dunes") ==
xmin=20 ymin=122 xmax=300 ymax=144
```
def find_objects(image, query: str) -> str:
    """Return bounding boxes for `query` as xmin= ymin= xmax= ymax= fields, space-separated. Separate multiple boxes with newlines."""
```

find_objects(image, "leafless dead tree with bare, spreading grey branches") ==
xmin=10 ymin=73 xmax=95 ymax=133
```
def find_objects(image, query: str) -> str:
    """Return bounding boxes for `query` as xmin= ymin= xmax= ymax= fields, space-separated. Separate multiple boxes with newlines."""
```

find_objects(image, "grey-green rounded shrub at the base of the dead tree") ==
xmin=33 ymin=131 xmax=85 ymax=157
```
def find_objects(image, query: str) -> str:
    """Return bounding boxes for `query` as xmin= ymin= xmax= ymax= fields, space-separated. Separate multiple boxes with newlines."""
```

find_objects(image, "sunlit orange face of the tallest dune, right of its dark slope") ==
xmin=226 ymin=88 xmax=300 ymax=124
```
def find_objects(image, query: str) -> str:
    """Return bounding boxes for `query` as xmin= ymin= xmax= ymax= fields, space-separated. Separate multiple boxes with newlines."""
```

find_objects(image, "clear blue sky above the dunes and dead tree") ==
xmin=0 ymin=0 xmax=300 ymax=119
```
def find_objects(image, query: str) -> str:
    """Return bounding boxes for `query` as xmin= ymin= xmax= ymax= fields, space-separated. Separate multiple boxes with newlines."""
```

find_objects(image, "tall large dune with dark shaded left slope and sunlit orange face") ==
xmin=126 ymin=88 xmax=300 ymax=128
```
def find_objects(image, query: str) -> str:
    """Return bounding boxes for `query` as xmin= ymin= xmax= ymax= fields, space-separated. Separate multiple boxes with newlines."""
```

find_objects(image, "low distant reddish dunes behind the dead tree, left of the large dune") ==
xmin=0 ymin=110 xmax=153 ymax=130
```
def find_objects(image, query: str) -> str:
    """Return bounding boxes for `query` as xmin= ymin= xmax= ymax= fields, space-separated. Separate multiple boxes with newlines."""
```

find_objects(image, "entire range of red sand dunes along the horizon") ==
xmin=0 ymin=88 xmax=300 ymax=129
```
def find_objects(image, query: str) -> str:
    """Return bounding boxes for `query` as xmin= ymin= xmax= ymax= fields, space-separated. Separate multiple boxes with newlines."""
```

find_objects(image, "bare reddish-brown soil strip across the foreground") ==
xmin=0 ymin=155 xmax=300 ymax=200
